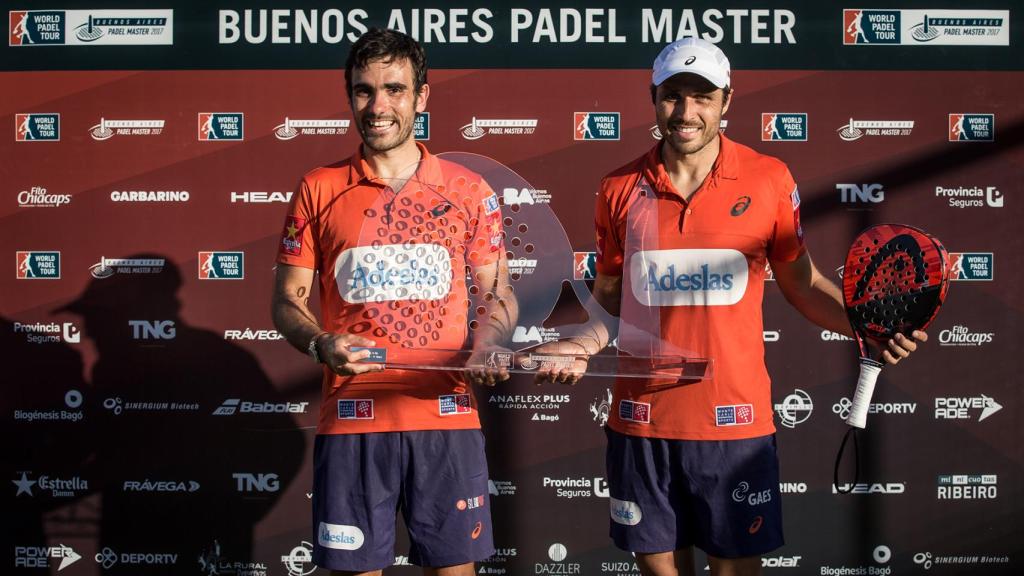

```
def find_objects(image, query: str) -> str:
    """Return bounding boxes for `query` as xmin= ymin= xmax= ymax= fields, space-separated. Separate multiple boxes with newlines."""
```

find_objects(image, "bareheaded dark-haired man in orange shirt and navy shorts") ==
xmin=272 ymin=29 xmax=515 ymax=576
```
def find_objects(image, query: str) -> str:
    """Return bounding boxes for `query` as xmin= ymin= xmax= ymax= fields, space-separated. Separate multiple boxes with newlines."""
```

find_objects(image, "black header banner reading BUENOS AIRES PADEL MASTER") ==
xmin=0 ymin=0 xmax=1024 ymax=71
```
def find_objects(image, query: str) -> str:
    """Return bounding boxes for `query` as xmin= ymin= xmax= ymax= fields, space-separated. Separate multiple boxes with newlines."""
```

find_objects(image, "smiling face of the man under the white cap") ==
xmin=654 ymin=74 xmax=730 ymax=156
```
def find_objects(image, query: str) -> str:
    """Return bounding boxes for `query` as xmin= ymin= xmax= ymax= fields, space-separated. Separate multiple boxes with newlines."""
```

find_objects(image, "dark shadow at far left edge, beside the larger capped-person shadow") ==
xmin=0 ymin=318 xmax=96 ymax=573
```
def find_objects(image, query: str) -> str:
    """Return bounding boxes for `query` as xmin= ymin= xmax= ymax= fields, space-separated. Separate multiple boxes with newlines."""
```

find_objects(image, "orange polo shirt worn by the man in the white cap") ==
xmin=596 ymin=135 xmax=804 ymax=440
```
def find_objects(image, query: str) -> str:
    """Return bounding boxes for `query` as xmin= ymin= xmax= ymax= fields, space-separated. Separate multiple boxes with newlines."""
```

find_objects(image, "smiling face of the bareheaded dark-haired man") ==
xmin=350 ymin=58 xmax=430 ymax=152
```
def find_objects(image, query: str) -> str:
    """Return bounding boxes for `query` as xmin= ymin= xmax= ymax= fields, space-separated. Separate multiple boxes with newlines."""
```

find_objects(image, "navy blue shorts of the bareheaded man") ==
xmin=312 ymin=429 xmax=495 ymax=572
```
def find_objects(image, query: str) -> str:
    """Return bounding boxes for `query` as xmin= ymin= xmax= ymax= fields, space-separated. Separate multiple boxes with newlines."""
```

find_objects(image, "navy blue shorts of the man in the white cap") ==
xmin=605 ymin=427 xmax=784 ymax=558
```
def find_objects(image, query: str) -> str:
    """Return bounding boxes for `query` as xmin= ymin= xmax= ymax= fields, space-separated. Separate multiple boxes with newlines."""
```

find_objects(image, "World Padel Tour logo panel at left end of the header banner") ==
xmin=7 ymin=10 xmax=174 ymax=46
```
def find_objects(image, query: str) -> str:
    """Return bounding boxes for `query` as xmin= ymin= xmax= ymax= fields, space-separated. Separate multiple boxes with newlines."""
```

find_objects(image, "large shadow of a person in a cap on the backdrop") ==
xmin=61 ymin=254 xmax=305 ymax=574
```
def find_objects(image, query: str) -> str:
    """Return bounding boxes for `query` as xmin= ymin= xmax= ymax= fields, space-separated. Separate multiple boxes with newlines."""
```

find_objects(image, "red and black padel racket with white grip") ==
xmin=843 ymin=224 xmax=949 ymax=428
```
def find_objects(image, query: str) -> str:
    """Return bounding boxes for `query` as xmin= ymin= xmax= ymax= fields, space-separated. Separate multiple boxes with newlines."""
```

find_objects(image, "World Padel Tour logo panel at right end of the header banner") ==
xmin=843 ymin=8 xmax=1010 ymax=46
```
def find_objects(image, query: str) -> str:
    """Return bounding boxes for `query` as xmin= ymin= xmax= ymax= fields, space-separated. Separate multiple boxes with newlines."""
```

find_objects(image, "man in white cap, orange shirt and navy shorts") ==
xmin=539 ymin=38 xmax=927 ymax=576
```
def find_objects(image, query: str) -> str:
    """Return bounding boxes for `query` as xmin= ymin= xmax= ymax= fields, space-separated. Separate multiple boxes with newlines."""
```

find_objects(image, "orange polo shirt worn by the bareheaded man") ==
xmin=278 ymin=142 xmax=504 ymax=434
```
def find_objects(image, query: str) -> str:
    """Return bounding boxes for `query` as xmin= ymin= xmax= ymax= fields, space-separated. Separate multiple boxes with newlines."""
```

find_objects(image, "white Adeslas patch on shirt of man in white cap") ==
xmin=630 ymin=248 xmax=748 ymax=306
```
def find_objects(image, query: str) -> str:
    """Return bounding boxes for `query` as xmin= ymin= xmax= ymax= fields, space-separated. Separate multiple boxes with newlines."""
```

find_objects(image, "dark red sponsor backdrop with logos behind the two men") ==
xmin=0 ymin=0 xmax=1024 ymax=576
